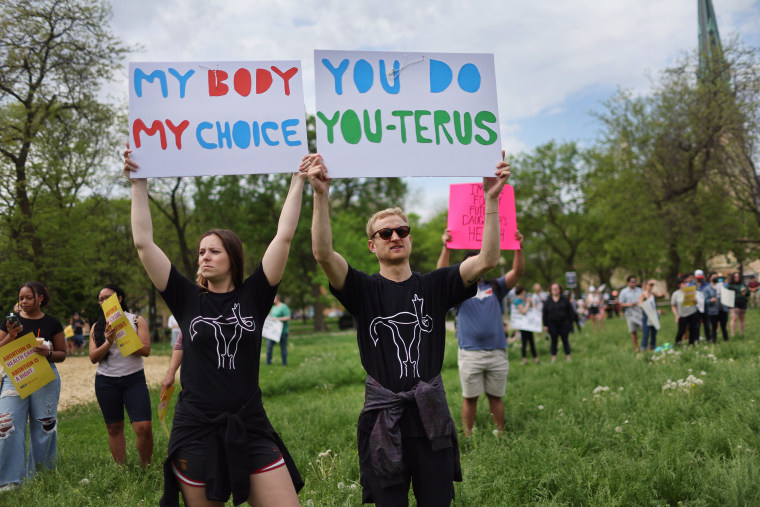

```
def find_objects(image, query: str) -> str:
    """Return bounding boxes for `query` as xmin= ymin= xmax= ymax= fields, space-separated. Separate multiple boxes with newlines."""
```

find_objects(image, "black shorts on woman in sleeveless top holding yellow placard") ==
xmin=95 ymin=370 xmax=151 ymax=424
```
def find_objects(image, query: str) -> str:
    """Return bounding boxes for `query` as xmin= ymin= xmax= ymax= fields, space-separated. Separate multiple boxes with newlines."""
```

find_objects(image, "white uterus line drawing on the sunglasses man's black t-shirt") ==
xmin=369 ymin=294 xmax=433 ymax=378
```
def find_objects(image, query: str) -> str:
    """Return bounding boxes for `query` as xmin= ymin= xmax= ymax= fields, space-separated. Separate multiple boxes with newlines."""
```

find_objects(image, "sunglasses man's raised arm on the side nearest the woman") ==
xmin=301 ymin=155 xmax=348 ymax=291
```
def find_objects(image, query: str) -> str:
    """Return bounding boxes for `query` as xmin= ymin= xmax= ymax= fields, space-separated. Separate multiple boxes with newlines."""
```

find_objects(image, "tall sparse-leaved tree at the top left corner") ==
xmin=0 ymin=0 xmax=127 ymax=278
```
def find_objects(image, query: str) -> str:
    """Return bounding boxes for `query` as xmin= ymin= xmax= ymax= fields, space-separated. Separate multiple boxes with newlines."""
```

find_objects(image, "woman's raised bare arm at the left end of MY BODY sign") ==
xmin=124 ymin=143 xmax=172 ymax=291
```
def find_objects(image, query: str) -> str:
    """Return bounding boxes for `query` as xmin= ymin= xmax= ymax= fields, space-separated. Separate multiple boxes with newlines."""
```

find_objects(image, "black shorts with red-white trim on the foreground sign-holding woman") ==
xmin=172 ymin=437 xmax=285 ymax=488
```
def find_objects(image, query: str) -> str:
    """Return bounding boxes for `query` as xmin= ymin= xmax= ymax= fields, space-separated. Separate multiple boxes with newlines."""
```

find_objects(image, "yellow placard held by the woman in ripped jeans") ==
xmin=0 ymin=333 xmax=55 ymax=398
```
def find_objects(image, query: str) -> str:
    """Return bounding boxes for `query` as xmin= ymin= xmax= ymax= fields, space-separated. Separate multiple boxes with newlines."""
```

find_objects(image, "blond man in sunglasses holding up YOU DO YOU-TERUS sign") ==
xmin=301 ymin=155 xmax=510 ymax=505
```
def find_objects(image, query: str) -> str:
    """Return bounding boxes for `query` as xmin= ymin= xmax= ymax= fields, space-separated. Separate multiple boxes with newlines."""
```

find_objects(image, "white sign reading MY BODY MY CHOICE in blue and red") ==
xmin=129 ymin=61 xmax=309 ymax=178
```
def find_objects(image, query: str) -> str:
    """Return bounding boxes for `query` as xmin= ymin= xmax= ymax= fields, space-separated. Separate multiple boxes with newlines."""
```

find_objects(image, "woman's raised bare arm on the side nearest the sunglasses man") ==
xmin=261 ymin=173 xmax=306 ymax=286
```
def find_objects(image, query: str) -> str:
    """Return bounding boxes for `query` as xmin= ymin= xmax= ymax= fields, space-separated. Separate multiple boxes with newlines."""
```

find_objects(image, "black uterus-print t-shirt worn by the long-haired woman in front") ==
xmin=161 ymin=264 xmax=277 ymax=417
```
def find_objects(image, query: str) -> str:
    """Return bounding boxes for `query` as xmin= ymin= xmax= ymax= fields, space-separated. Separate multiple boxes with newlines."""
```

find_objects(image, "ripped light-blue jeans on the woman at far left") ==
xmin=0 ymin=363 xmax=61 ymax=485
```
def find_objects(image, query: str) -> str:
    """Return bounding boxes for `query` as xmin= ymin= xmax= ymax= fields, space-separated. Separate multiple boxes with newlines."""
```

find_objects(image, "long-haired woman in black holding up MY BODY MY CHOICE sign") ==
xmin=124 ymin=146 xmax=306 ymax=506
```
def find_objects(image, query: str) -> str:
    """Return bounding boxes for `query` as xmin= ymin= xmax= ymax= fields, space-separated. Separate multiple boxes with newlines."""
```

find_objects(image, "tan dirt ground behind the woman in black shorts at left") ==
xmin=55 ymin=356 xmax=169 ymax=411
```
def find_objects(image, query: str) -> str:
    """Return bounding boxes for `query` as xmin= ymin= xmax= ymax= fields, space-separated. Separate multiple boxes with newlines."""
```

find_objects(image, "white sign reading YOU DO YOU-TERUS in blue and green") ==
xmin=314 ymin=50 xmax=501 ymax=178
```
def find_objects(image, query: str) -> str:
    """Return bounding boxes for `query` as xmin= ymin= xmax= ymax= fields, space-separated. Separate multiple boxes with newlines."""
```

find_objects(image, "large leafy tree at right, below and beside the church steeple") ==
xmin=589 ymin=42 xmax=756 ymax=290
